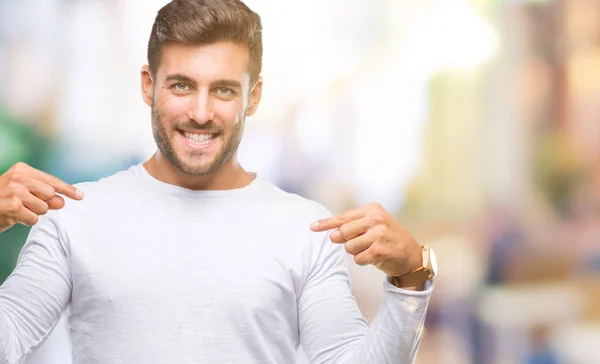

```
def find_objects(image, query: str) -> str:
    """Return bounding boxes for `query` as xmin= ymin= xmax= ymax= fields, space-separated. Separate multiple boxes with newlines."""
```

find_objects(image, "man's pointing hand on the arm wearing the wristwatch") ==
xmin=311 ymin=203 xmax=422 ymax=276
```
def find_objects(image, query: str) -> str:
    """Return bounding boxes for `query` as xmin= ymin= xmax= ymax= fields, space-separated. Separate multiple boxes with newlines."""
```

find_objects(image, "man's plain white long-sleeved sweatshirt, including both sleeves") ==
xmin=0 ymin=165 xmax=432 ymax=364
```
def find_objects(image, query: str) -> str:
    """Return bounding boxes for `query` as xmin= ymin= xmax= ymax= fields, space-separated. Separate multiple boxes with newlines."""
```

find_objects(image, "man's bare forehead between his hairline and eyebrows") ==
xmin=158 ymin=41 xmax=250 ymax=83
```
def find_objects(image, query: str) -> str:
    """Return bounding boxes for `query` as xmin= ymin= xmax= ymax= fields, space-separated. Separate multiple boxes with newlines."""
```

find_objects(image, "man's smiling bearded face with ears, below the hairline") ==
xmin=142 ymin=42 xmax=262 ymax=175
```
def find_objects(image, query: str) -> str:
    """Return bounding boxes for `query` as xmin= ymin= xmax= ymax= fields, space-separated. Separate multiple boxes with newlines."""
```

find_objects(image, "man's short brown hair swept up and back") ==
xmin=148 ymin=0 xmax=263 ymax=82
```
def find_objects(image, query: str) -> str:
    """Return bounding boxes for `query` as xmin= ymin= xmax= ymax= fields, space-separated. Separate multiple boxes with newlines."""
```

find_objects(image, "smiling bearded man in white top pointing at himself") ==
xmin=0 ymin=0 xmax=435 ymax=364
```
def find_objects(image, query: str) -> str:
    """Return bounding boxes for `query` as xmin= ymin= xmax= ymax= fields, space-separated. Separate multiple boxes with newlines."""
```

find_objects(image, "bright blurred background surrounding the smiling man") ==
xmin=0 ymin=0 xmax=600 ymax=364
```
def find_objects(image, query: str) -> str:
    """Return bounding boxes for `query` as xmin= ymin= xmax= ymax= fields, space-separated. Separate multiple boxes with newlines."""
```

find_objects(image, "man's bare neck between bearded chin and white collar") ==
xmin=144 ymin=151 xmax=253 ymax=190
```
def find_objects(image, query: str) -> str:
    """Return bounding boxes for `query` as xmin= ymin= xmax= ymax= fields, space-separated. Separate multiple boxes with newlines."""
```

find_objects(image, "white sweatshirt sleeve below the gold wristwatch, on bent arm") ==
xmin=298 ymin=232 xmax=433 ymax=364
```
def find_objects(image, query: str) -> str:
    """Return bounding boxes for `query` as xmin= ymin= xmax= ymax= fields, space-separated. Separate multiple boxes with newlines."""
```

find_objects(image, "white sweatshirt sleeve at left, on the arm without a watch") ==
xmin=0 ymin=211 xmax=72 ymax=364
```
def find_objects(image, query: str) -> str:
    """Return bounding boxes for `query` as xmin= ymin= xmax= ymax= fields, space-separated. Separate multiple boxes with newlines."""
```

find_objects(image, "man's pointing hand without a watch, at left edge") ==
xmin=0 ymin=162 xmax=83 ymax=232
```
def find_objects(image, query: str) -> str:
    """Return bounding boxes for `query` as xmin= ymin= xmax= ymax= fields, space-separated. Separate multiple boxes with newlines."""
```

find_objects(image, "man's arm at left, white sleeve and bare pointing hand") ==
xmin=0 ymin=163 xmax=83 ymax=364
